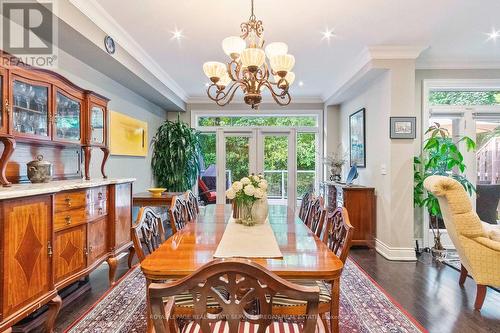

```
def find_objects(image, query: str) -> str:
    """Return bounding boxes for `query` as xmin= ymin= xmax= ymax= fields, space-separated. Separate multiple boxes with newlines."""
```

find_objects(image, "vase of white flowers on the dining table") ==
xmin=226 ymin=175 xmax=267 ymax=225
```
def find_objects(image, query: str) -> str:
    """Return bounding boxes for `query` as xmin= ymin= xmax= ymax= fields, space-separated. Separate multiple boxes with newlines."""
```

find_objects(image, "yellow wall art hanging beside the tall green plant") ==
xmin=109 ymin=111 xmax=148 ymax=156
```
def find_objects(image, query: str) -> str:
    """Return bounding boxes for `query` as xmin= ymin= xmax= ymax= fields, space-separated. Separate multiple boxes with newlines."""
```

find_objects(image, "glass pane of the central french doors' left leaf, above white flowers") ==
xmin=225 ymin=136 xmax=250 ymax=188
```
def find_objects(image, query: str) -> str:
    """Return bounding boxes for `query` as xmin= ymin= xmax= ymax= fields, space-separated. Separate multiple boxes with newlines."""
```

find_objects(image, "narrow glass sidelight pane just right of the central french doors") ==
xmin=297 ymin=133 xmax=317 ymax=200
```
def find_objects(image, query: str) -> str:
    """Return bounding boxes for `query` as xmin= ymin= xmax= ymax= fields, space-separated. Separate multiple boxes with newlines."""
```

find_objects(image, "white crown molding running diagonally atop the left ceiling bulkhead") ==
xmin=70 ymin=0 xmax=188 ymax=102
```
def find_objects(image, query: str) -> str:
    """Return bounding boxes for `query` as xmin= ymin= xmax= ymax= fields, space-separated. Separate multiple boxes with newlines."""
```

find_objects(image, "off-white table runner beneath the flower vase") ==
xmin=214 ymin=216 xmax=283 ymax=259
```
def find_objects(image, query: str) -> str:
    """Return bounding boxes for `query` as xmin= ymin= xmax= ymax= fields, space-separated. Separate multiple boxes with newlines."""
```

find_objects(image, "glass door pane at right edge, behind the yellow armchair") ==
xmin=476 ymin=119 xmax=500 ymax=224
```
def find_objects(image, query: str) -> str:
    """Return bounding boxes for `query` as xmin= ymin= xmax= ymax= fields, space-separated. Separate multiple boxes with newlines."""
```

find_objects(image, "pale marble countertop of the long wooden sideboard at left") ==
xmin=0 ymin=178 xmax=135 ymax=200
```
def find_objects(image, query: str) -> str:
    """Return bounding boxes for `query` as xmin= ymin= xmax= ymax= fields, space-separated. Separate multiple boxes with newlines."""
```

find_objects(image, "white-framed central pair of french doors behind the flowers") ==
xmin=216 ymin=128 xmax=297 ymax=207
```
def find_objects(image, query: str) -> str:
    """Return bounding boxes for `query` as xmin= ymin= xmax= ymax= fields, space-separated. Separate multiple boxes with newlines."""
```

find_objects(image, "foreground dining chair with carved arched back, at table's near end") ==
xmin=148 ymin=259 xmax=325 ymax=333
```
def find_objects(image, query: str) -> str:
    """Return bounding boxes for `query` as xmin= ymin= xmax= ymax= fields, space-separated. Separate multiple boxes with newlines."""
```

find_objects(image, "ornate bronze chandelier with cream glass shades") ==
xmin=203 ymin=0 xmax=295 ymax=109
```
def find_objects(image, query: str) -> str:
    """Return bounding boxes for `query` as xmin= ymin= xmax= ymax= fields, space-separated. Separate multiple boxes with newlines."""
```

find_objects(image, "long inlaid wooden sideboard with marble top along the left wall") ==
xmin=0 ymin=179 xmax=134 ymax=332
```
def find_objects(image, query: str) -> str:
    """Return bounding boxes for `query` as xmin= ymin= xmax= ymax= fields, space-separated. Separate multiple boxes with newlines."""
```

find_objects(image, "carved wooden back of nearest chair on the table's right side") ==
xmin=323 ymin=207 xmax=354 ymax=264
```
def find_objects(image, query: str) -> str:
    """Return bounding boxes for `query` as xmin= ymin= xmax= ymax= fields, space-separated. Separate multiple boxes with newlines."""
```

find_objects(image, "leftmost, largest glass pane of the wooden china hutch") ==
xmin=13 ymin=80 xmax=49 ymax=136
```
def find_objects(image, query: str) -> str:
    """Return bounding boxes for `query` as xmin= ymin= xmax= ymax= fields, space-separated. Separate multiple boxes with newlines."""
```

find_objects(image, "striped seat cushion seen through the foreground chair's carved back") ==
xmin=181 ymin=320 xmax=323 ymax=333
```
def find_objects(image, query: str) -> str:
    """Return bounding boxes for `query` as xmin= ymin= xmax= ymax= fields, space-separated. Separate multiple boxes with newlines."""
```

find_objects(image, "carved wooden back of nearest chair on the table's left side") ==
xmin=131 ymin=207 xmax=165 ymax=261
